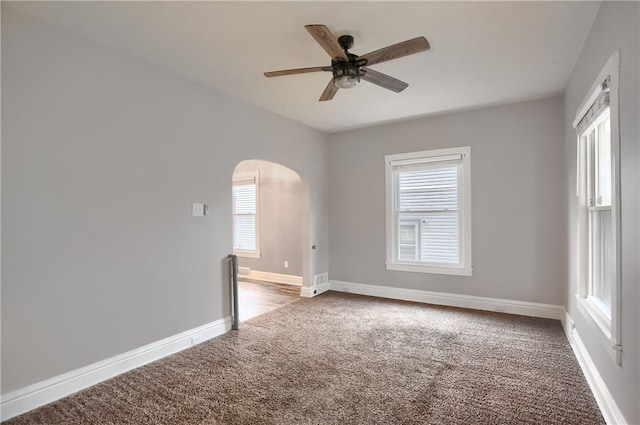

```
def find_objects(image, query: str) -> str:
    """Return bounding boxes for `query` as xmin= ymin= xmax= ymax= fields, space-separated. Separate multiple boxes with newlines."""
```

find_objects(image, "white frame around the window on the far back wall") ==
xmin=385 ymin=146 xmax=472 ymax=276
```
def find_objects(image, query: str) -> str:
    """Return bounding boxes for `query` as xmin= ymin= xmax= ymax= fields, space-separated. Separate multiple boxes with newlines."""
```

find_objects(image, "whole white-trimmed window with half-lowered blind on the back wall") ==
xmin=385 ymin=147 xmax=471 ymax=276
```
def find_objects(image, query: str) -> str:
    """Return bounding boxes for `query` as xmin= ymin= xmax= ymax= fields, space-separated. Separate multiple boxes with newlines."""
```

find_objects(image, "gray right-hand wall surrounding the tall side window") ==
xmin=564 ymin=2 xmax=640 ymax=424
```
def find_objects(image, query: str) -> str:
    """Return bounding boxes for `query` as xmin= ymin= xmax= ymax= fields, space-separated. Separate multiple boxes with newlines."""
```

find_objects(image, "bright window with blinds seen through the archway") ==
xmin=233 ymin=171 xmax=260 ymax=258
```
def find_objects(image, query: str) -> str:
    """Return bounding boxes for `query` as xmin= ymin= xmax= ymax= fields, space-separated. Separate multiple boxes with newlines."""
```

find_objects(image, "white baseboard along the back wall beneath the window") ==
xmin=330 ymin=280 xmax=564 ymax=320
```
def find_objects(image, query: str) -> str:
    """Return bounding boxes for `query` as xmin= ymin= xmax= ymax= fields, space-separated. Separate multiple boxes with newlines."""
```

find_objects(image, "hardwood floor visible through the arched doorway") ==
xmin=238 ymin=279 xmax=300 ymax=322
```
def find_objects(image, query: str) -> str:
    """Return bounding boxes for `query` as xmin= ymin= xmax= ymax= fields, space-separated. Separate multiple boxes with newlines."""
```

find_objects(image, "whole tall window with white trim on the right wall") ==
xmin=574 ymin=52 xmax=621 ymax=363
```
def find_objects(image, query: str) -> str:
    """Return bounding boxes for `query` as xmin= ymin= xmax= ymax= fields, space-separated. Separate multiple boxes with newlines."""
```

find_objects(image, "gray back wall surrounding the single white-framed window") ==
xmin=329 ymin=97 xmax=566 ymax=304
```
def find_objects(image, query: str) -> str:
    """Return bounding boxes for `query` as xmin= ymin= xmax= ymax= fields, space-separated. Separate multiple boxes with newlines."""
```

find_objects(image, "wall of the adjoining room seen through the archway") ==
xmin=234 ymin=161 xmax=302 ymax=276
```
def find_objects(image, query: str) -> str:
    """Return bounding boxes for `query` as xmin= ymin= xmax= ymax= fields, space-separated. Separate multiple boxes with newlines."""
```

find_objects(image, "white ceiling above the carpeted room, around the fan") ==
xmin=8 ymin=1 xmax=600 ymax=133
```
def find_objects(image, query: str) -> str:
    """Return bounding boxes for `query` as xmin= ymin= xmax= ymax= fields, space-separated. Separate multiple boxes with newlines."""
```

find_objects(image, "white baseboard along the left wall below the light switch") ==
xmin=0 ymin=317 xmax=231 ymax=421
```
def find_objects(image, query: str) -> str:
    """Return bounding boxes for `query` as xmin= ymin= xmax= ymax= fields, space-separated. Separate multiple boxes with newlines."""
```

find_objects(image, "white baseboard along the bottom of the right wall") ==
xmin=562 ymin=312 xmax=627 ymax=425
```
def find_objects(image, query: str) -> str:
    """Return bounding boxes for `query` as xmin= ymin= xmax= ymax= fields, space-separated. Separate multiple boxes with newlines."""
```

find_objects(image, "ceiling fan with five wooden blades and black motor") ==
xmin=264 ymin=25 xmax=431 ymax=102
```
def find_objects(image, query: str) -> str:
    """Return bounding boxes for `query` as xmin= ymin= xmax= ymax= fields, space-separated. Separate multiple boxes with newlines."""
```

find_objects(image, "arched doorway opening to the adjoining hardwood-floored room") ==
xmin=232 ymin=160 xmax=305 ymax=321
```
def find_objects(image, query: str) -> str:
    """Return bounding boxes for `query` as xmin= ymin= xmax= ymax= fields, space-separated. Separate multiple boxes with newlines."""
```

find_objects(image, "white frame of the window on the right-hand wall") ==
xmin=573 ymin=51 xmax=622 ymax=364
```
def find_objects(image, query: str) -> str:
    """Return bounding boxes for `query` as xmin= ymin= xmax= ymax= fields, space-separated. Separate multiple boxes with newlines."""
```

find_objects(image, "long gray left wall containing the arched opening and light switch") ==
xmin=1 ymin=7 xmax=328 ymax=394
